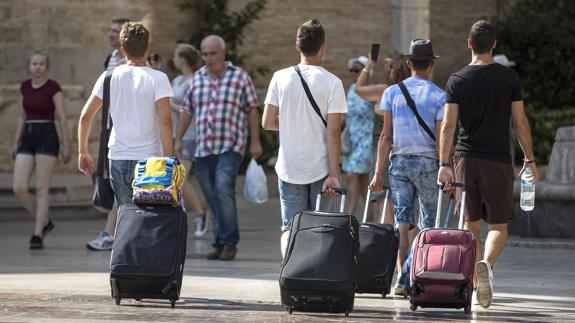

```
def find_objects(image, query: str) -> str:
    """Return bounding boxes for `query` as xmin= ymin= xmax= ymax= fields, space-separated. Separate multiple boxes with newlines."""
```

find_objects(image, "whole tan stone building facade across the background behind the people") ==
xmin=0 ymin=0 xmax=509 ymax=172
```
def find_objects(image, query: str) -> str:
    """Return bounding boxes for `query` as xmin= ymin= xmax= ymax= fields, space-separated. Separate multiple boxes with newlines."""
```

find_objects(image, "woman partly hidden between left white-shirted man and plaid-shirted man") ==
xmin=171 ymin=44 xmax=208 ymax=237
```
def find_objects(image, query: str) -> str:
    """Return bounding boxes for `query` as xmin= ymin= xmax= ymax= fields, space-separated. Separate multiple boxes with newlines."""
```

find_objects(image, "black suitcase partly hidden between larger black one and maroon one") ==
xmin=356 ymin=188 xmax=399 ymax=297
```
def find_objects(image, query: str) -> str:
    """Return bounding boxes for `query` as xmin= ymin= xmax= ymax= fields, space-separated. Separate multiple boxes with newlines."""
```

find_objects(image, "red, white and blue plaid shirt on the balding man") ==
xmin=184 ymin=62 xmax=259 ymax=157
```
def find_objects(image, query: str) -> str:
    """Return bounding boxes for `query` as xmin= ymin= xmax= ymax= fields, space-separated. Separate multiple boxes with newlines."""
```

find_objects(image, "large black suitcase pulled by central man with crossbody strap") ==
xmin=279 ymin=190 xmax=359 ymax=316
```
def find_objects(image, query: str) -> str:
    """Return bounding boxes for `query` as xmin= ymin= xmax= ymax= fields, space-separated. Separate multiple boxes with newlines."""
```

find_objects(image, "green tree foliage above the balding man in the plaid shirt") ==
xmin=179 ymin=0 xmax=267 ymax=73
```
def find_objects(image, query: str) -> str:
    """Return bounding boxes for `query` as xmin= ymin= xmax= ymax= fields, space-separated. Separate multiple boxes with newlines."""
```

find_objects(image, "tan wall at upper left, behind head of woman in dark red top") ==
xmin=0 ymin=0 xmax=194 ymax=93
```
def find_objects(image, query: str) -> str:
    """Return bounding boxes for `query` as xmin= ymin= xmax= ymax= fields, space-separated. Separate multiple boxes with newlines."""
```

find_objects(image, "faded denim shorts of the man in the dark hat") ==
xmin=389 ymin=155 xmax=439 ymax=230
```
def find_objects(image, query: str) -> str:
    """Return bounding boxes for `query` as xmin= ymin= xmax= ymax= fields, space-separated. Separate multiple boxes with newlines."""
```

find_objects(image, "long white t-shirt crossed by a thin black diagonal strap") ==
xmin=265 ymin=64 xmax=347 ymax=184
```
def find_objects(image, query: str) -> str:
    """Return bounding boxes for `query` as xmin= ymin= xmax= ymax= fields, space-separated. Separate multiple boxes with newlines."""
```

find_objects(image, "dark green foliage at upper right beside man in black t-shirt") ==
xmin=495 ymin=0 xmax=575 ymax=110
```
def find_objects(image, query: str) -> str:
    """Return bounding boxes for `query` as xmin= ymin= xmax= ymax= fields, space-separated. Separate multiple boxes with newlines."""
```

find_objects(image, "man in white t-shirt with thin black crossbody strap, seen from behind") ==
xmin=262 ymin=19 xmax=347 ymax=255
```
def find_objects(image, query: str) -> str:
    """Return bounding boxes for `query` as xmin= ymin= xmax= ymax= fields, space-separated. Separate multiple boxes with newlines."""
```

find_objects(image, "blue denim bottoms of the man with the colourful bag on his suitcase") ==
xmin=110 ymin=160 xmax=138 ymax=207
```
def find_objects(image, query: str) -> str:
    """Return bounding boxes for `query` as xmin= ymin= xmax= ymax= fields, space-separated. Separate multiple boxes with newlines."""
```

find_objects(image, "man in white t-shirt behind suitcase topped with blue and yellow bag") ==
xmin=78 ymin=22 xmax=173 ymax=206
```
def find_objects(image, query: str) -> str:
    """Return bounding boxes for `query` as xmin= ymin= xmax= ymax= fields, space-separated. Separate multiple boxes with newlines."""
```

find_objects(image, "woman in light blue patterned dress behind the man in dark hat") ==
xmin=341 ymin=56 xmax=374 ymax=218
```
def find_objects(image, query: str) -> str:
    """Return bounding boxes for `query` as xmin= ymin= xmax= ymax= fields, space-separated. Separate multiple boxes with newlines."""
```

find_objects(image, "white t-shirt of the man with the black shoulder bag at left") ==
xmin=92 ymin=65 xmax=173 ymax=160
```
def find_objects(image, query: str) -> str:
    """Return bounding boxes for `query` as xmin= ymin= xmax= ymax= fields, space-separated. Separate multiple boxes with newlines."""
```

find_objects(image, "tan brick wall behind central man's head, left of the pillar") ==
xmin=233 ymin=0 xmax=390 ymax=87
